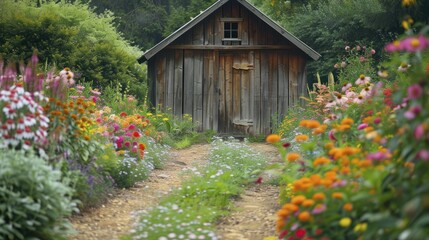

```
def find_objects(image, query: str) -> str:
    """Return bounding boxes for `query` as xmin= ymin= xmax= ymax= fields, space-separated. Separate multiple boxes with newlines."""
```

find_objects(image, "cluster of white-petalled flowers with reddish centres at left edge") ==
xmin=0 ymin=85 xmax=49 ymax=149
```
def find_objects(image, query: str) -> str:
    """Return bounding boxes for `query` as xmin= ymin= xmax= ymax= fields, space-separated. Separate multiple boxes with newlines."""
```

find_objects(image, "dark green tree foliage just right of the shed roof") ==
xmin=291 ymin=0 xmax=392 ymax=79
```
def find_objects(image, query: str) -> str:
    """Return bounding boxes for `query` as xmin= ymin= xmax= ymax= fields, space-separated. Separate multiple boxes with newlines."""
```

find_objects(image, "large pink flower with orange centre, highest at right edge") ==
xmin=385 ymin=35 xmax=429 ymax=53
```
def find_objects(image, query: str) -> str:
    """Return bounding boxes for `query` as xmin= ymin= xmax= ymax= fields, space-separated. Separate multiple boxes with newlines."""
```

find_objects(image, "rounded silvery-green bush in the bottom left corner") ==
xmin=0 ymin=150 xmax=77 ymax=239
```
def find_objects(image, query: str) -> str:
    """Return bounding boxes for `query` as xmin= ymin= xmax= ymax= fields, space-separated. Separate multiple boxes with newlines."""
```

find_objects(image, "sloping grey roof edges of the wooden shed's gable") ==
xmin=139 ymin=0 xmax=320 ymax=62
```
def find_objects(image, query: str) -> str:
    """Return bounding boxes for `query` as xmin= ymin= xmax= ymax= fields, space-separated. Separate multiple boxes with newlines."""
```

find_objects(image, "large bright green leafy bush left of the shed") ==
xmin=0 ymin=0 xmax=145 ymax=101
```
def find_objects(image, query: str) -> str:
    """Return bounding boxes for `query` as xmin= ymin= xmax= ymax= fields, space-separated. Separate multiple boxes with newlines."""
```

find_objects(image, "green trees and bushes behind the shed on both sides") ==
xmin=0 ymin=0 xmax=429 ymax=97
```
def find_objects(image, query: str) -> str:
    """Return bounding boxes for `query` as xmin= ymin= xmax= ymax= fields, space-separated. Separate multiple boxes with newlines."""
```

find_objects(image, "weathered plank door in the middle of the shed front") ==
xmin=218 ymin=52 xmax=253 ymax=134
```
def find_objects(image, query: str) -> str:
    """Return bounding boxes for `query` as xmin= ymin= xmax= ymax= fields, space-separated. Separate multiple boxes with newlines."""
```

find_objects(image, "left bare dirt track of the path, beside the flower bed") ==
xmin=69 ymin=145 xmax=210 ymax=240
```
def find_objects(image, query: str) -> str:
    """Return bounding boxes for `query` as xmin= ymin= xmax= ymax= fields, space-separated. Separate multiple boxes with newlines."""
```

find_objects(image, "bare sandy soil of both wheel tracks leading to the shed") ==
xmin=69 ymin=143 xmax=279 ymax=240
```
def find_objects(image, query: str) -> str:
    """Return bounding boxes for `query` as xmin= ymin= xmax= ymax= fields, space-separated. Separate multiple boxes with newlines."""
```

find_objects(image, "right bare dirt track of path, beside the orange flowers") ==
xmin=217 ymin=144 xmax=280 ymax=240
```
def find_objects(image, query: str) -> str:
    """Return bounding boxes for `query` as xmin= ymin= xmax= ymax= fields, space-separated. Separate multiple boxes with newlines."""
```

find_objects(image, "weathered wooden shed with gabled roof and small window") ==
xmin=140 ymin=0 xmax=320 ymax=135
